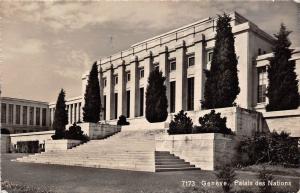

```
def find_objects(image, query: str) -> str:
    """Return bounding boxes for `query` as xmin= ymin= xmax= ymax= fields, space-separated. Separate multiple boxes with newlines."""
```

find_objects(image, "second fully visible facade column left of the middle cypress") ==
xmin=117 ymin=61 xmax=126 ymax=116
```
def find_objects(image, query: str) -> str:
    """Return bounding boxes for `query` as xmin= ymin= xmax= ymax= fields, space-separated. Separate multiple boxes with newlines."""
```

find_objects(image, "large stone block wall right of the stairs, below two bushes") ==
xmin=155 ymin=133 xmax=236 ymax=170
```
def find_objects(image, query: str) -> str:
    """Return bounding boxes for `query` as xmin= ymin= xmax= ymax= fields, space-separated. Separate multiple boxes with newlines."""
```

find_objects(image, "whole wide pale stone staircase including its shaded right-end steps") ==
xmin=15 ymin=130 xmax=196 ymax=172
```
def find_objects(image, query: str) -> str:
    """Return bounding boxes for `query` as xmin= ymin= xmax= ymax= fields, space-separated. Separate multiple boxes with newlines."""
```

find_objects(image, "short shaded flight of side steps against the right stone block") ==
xmin=155 ymin=151 xmax=199 ymax=172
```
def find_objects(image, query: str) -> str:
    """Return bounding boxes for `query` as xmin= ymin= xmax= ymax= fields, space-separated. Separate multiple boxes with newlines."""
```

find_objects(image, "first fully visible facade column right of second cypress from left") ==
xmin=106 ymin=67 xmax=114 ymax=120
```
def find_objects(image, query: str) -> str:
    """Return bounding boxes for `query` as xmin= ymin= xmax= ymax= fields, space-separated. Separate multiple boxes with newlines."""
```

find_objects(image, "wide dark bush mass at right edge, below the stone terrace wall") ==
xmin=238 ymin=132 xmax=299 ymax=166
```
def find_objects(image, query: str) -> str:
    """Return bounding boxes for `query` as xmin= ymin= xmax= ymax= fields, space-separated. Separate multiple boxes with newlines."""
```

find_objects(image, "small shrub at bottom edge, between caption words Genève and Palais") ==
xmin=216 ymin=164 xmax=236 ymax=193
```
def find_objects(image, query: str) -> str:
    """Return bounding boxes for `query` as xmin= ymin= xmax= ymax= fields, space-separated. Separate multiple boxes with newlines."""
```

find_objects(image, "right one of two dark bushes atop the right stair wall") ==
xmin=194 ymin=110 xmax=233 ymax=134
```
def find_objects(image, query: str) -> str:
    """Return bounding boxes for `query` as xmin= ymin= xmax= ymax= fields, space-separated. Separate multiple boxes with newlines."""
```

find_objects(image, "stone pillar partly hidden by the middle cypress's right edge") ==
xmin=159 ymin=46 xmax=170 ymax=112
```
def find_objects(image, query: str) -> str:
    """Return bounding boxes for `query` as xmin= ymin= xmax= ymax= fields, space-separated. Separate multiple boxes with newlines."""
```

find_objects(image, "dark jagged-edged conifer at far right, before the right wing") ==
xmin=266 ymin=24 xmax=299 ymax=111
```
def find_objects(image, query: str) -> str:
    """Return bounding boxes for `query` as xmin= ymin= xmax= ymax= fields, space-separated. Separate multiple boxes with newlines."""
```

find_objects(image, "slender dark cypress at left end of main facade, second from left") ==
xmin=83 ymin=62 xmax=101 ymax=123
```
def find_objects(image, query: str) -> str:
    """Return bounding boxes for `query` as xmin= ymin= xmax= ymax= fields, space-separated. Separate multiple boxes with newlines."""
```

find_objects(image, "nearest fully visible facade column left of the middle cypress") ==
xmin=130 ymin=56 xmax=139 ymax=118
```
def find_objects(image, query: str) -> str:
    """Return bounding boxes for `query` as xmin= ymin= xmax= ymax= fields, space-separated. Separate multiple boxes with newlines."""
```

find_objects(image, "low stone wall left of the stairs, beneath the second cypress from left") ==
xmin=78 ymin=123 xmax=121 ymax=139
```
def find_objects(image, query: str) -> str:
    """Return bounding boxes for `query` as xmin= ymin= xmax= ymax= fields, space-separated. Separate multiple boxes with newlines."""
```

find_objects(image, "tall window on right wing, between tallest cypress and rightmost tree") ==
xmin=257 ymin=67 xmax=267 ymax=103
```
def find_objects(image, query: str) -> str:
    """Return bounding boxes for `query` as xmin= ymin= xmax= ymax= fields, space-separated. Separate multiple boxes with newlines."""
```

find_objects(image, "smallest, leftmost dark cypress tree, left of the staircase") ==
xmin=52 ymin=89 xmax=68 ymax=139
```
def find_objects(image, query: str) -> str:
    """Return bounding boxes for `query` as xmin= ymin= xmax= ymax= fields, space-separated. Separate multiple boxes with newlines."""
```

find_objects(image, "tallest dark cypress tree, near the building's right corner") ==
xmin=201 ymin=13 xmax=240 ymax=109
